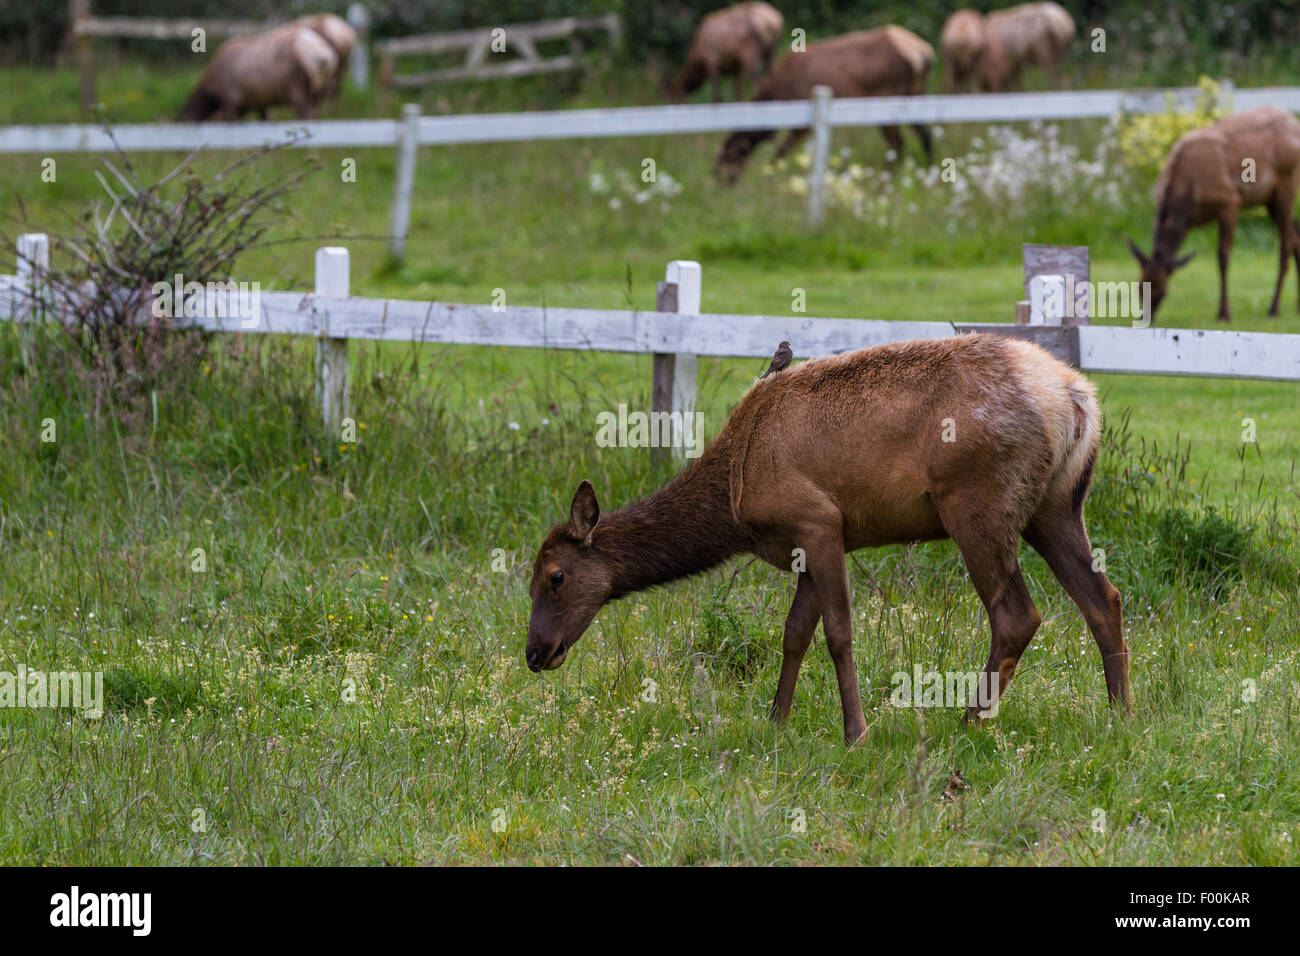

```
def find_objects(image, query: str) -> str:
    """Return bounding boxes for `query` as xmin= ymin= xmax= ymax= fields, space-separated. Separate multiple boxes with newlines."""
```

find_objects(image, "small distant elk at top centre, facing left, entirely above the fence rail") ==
xmin=668 ymin=0 xmax=785 ymax=103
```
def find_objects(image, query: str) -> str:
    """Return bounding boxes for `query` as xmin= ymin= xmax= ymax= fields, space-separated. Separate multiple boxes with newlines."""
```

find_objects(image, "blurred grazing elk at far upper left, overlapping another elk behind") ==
xmin=178 ymin=23 xmax=338 ymax=122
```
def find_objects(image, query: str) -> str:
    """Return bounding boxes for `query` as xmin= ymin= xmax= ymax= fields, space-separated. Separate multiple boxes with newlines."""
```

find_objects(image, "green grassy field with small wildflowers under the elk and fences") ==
xmin=0 ymin=64 xmax=1300 ymax=865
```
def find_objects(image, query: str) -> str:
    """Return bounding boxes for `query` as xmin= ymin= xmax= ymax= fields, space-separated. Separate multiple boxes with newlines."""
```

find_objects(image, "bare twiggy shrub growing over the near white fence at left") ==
xmin=0 ymin=127 xmax=304 ymax=411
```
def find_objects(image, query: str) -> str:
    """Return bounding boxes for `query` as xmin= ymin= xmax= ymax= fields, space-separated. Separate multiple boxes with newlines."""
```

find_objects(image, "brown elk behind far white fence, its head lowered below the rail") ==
xmin=714 ymin=26 xmax=935 ymax=183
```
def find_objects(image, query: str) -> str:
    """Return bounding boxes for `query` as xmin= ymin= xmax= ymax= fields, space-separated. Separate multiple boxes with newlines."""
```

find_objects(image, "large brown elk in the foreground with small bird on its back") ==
xmin=524 ymin=336 xmax=1131 ymax=743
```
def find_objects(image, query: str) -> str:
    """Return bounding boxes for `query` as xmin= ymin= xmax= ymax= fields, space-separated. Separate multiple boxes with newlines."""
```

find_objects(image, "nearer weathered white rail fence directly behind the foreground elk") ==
xmin=0 ymin=234 xmax=1300 ymax=463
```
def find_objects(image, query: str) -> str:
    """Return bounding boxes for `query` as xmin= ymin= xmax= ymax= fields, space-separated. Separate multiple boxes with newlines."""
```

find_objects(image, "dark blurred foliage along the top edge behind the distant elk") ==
xmin=10 ymin=0 xmax=1300 ymax=70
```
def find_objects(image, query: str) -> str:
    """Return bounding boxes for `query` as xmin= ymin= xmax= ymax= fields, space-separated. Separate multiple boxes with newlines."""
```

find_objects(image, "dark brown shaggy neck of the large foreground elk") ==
xmin=592 ymin=444 xmax=751 ymax=600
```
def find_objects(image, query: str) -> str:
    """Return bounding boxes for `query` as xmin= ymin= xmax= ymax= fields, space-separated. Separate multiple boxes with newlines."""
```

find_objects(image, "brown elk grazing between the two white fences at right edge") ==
xmin=1128 ymin=107 xmax=1300 ymax=323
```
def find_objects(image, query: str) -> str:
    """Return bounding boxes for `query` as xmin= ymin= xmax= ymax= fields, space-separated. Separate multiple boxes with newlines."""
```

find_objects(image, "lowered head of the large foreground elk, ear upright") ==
xmin=524 ymin=481 xmax=614 ymax=672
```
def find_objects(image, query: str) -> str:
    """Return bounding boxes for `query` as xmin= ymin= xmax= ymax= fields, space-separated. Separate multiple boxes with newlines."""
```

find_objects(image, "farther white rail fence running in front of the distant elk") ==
xmin=10 ymin=83 xmax=1300 ymax=258
